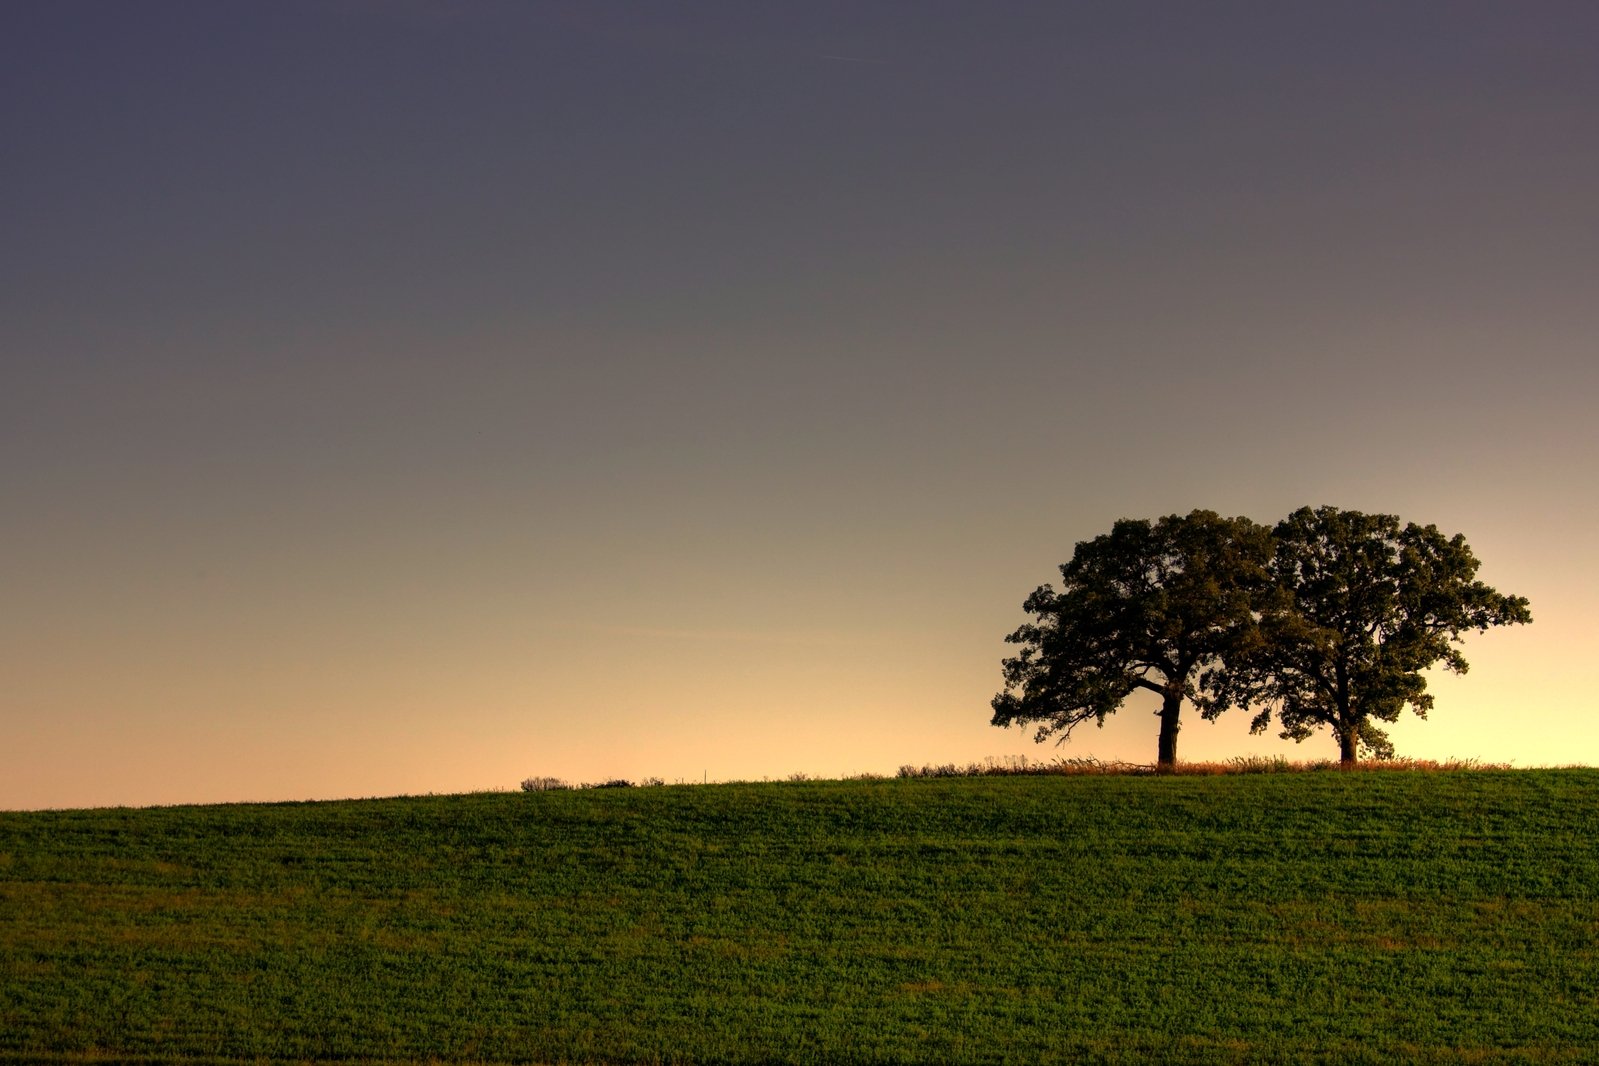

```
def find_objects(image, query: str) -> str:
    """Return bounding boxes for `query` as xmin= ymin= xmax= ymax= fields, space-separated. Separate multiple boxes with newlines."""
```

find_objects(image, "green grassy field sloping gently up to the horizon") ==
xmin=0 ymin=770 xmax=1599 ymax=1063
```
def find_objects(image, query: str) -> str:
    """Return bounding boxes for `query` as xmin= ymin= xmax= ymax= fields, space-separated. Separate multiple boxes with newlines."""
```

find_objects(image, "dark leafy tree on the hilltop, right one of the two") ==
xmin=1220 ymin=507 xmax=1532 ymax=766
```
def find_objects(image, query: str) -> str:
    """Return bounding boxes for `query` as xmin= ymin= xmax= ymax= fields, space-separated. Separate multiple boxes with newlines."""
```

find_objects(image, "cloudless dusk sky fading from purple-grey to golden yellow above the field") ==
xmin=0 ymin=0 xmax=1599 ymax=809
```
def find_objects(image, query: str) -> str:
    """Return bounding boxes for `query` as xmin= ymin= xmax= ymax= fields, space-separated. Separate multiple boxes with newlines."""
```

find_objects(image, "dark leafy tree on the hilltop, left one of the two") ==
xmin=993 ymin=511 xmax=1271 ymax=767
